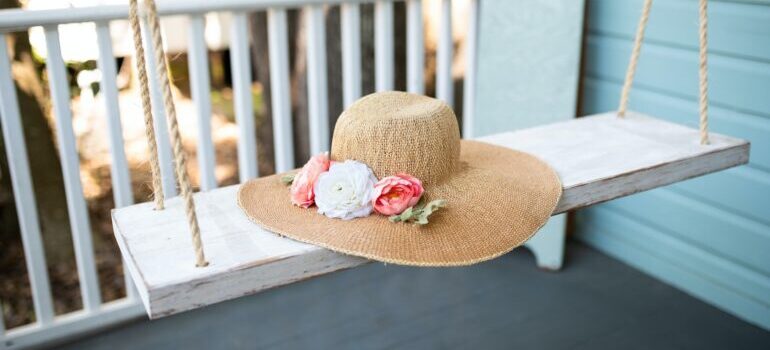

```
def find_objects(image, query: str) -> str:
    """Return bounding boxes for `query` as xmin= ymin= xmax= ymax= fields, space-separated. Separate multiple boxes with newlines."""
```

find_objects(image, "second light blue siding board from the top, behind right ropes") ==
xmin=585 ymin=35 xmax=770 ymax=119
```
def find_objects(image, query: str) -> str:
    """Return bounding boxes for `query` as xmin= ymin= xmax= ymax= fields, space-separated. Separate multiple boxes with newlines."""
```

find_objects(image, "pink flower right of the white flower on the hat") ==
xmin=372 ymin=174 xmax=425 ymax=215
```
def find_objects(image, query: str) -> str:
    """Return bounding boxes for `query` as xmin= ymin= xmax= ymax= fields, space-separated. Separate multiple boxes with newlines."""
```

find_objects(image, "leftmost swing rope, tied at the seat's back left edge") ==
xmin=128 ymin=0 xmax=163 ymax=210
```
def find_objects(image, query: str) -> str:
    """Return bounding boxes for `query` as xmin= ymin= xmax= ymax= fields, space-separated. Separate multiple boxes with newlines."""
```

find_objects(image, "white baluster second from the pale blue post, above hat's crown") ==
xmin=436 ymin=0 xmax=454 ymax=107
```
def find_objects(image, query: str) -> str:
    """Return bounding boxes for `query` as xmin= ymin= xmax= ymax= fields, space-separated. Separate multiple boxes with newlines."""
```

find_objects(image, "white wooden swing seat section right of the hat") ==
xmin=481 ymin=112 xmax=749 ymax=214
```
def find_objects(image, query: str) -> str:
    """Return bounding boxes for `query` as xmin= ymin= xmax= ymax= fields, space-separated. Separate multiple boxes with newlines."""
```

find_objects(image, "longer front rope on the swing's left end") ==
xmin=142 ymin=0 xmax=208 ymax=267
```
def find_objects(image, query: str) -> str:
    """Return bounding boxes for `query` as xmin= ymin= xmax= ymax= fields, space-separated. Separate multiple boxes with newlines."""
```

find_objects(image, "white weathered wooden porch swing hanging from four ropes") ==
xmin=112 ymin=0 xmax=749 ymax=318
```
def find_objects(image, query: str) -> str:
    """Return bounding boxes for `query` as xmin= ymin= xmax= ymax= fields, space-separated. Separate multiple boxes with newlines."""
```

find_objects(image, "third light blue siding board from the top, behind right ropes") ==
xmin=581 ymin=78 xmax=770 ymax=174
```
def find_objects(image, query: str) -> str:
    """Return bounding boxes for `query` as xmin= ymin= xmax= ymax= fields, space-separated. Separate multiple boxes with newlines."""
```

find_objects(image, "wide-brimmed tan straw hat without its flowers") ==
xmin=238 ymin=92 xmax=562 ymax=266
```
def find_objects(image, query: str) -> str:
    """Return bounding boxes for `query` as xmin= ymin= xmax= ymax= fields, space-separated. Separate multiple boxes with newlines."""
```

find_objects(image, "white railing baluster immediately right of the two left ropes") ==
xmin=187 ymin=15 xmax=217 ymax=191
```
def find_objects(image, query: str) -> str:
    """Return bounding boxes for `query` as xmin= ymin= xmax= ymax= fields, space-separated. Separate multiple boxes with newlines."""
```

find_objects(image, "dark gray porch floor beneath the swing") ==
xmin=55 ymin=242 xmax=770 ymax=350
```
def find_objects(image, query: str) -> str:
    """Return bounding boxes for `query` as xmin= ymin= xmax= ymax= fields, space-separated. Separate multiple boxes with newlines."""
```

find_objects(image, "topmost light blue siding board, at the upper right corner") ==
xmin=587 ymin=0 xmax=770 ymax=61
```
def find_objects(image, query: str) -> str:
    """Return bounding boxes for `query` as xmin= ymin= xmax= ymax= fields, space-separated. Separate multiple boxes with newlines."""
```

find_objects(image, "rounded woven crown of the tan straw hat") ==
xmin=331 ymin=91 xmax=460 ymax=185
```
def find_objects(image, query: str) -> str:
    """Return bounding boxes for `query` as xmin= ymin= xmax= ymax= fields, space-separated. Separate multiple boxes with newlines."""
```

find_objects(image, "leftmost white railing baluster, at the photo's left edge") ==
xmin=0 ymin=33 xmax=54 ymax=329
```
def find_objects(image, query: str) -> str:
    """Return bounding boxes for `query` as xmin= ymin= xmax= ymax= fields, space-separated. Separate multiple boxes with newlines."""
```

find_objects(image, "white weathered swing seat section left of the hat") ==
xmin=113 ymin=185 xmax=366 ymax=318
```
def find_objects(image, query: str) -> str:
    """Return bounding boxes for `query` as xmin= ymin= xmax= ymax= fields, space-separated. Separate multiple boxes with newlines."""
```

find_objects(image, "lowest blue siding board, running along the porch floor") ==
xmin=576 ymin=209 xmax=770 ymax=329
